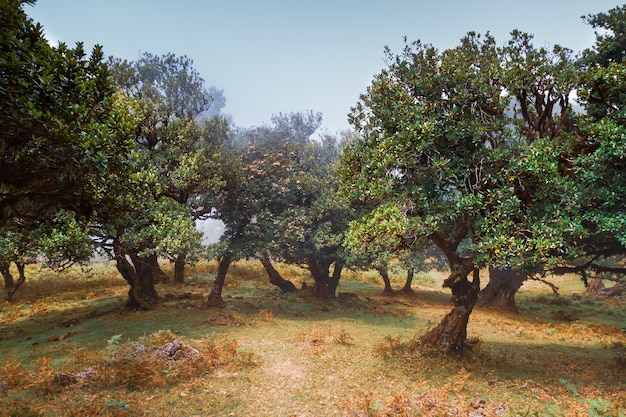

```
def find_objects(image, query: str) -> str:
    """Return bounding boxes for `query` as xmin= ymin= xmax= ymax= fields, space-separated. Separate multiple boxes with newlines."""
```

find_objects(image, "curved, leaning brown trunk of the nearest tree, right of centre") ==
xmin=420 ymin=267 xmax=480 ymax=352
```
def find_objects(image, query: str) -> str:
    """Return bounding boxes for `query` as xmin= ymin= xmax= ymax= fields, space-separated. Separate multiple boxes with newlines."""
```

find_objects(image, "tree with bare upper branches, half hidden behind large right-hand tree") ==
xmin=479 ymin=31 xmax=578 ymax=312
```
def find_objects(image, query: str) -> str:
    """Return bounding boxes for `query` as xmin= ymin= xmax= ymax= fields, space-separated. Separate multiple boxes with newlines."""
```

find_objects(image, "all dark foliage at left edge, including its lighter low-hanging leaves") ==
xmin=0 ymin=1 xmax=132 ymax=298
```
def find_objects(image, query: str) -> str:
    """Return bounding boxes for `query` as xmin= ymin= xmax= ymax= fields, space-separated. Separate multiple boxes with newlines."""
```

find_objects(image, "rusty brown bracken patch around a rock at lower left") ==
xmin=0 ymin=330 xmax=256 ymax=416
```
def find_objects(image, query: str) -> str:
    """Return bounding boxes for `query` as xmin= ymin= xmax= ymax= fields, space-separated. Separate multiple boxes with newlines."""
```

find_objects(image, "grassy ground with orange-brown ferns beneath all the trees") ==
xmin=0 ymin=262 xmax=626 ymax=417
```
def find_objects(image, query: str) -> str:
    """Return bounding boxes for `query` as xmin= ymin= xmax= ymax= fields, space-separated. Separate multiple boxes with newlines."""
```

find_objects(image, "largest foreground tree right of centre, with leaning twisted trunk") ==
xmin=342 ymin=33 xmax=579 ymax=351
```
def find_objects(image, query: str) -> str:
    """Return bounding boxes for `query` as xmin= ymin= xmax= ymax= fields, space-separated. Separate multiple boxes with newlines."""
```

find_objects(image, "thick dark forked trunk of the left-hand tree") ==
xmin=113 ymin=243 xmax=159 ymax=310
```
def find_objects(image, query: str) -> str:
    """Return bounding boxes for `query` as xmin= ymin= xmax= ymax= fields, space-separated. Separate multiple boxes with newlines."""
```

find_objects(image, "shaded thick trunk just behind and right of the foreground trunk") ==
xmin=478 ymin=267 xmax=527 ymax=313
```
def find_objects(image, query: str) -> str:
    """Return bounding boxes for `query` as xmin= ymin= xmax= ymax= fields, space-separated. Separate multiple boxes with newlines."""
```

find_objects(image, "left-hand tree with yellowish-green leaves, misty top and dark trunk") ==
xmin=94 ymin=54 xmax=228 ymax=308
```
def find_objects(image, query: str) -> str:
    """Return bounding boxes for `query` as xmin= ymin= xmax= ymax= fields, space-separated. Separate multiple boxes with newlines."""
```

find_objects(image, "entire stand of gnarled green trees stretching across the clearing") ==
xmin=0 ymin=0 xmax=626 ymax=351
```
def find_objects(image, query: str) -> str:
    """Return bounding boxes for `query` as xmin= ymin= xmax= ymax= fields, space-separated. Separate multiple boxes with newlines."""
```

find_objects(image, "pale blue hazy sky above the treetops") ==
xmin=25 ymin=0 xmax=623 ymax=133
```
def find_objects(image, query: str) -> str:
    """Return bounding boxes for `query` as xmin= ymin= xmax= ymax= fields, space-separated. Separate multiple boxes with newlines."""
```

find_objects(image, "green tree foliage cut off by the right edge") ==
xmin=557 ymin=6 xmax=626 ymax=287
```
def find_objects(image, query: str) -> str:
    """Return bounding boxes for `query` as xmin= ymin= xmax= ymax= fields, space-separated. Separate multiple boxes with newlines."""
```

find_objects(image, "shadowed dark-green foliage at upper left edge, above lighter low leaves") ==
xmin=0 ymin=0 xmax=129 ymax=227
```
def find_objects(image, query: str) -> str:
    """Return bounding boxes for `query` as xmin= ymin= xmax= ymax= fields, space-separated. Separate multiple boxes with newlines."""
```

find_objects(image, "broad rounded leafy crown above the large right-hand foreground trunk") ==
xmin=342 ymin=32 xmax=581 ymax=276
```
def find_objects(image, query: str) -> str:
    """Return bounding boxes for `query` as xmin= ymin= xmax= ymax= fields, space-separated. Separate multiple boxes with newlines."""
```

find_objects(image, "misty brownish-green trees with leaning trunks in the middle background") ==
xmin=209 ymin=112 xmax=347 ymax=304
